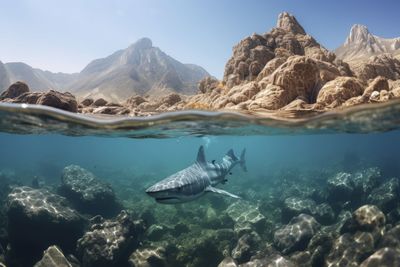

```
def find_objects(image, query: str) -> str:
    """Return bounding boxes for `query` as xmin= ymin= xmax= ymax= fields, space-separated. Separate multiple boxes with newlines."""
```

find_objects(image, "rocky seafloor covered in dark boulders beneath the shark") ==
xmin=0 ymin=162 xmax=400 ymax=267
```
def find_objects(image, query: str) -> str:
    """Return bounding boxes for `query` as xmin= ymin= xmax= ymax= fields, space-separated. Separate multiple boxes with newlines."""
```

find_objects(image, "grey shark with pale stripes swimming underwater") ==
xmin=146 ymin=146 xmax=247 ymax=204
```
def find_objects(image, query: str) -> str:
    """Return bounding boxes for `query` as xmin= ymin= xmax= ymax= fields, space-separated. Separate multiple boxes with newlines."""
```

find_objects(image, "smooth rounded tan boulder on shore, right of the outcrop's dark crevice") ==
xmin=317 ymin=77 xmax=364 ymax=108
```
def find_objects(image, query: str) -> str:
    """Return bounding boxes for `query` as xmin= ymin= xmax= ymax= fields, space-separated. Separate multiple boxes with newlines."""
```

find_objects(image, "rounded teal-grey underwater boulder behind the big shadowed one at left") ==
xmin=59 ymin=165 xmax=122 ymax=216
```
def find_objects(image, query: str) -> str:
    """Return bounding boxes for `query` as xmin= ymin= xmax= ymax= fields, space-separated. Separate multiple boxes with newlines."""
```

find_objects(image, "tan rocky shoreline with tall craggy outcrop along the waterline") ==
xmin=0 ymin=13 xmax=400 ymax=116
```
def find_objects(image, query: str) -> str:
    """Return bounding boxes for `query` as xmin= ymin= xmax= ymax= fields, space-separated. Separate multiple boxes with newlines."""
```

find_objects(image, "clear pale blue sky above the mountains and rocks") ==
xmin=0 ymin=0 xmax=400 ymax=78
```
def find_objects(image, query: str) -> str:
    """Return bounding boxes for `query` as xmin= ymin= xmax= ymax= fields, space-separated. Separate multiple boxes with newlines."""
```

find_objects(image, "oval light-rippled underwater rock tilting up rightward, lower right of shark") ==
xmin=274 ymin=214 xmax=320 ymax=254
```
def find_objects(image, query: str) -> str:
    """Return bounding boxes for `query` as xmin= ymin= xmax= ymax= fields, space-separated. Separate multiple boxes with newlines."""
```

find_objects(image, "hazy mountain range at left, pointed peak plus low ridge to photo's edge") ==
xmin=0 ymin=38 xmax=209 ymax=102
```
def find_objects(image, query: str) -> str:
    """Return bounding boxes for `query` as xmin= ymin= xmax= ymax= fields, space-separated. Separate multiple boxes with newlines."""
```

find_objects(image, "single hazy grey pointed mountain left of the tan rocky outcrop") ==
xmin=70 ymin=38 xmax=209 ymax=101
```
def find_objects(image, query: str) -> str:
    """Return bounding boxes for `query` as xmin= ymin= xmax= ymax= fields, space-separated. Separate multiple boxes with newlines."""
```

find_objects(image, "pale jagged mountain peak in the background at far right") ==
xmin=335 ymin=24 xmax=400 ymax=61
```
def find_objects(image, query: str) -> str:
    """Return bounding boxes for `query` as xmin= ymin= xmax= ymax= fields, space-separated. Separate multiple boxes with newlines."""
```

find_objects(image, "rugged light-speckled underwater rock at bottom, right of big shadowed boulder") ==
xmin=77 ymin=211 xmax=144 ymax=267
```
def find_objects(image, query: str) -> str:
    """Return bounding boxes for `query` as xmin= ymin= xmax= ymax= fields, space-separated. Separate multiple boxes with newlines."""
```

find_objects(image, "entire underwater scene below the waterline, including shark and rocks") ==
xmin=0 ymin=103 xmax=400 ymax=267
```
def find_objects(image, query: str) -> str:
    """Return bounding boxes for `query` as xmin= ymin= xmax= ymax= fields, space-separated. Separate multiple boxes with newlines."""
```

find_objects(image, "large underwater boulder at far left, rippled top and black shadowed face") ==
xmin=7 ymin=186 xmax=85 ymax=265
